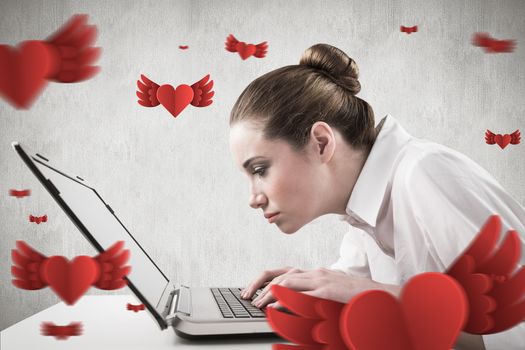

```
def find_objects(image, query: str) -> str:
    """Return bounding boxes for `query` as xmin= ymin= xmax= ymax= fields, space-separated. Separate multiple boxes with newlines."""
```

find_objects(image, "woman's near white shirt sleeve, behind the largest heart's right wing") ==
xmin=398 ymin=148 xmax=525 ymax=350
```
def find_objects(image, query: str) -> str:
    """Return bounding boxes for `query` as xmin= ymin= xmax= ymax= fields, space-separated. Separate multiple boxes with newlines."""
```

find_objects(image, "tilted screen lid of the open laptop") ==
xmin=12 ymin=142 xmax=169 ymax=329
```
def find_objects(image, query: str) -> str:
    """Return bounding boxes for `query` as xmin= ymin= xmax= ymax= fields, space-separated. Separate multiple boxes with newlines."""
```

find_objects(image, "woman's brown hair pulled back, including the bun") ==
xmin=230 ymin=44 xmax=376 ymax=151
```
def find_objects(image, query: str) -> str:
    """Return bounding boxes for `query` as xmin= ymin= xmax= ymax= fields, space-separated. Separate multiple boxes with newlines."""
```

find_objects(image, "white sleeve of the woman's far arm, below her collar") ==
xmin=329 ymin=226 xmax=370 ymax=277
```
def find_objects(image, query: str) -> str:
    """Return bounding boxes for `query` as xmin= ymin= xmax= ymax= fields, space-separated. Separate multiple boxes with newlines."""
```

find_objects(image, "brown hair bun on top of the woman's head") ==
xmin=299 ymin=44 xmax=361 ymax=95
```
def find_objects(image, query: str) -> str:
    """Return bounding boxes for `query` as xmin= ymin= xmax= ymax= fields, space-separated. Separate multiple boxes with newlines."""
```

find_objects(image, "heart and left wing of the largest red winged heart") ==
xmin=266 ymin=272 xmax=468 ymax=350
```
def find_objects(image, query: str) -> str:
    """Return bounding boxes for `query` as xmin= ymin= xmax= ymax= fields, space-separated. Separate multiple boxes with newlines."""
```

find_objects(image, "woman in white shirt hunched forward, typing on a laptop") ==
xmin=230 ymin=44 xmax=525 ymax=349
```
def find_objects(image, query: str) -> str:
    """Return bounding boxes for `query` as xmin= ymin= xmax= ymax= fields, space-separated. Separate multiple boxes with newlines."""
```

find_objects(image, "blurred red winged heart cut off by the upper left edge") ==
xmin=0 ymin=15 xmax=100 ymax=108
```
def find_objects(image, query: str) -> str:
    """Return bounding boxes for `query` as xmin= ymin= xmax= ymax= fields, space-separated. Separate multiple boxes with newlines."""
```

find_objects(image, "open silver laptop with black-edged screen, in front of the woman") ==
xmin=12 ymin=142 xmax=275 ymax=339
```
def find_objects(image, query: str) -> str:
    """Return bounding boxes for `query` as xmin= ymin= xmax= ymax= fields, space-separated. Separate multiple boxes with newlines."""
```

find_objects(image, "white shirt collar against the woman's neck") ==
xmin=346 ymin=114 xmax=412 ymax=227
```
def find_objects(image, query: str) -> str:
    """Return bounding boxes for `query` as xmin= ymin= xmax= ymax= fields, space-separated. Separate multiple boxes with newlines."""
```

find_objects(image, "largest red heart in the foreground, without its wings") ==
xmin=340 ymin=272 xmax=468 ymax=350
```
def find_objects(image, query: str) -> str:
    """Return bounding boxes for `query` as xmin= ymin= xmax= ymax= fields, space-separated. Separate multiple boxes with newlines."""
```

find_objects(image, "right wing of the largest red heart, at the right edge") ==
xmin=447 ymin=215 xmax=525 ymax=334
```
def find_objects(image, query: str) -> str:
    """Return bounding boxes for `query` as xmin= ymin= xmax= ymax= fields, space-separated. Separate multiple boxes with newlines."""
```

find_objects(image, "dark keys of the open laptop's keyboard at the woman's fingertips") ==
xmin=211 ymin=288 xmax=266 ymax=318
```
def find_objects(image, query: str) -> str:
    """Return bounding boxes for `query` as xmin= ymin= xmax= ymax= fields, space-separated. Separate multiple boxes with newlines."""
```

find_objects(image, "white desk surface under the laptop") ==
xmin=0 ymin=295 xmax=278 ymax=350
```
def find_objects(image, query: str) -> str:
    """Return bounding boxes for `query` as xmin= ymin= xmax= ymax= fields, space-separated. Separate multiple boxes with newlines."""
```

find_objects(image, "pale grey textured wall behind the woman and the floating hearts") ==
xmin=0 ymin=0 xmax=525 ymax=329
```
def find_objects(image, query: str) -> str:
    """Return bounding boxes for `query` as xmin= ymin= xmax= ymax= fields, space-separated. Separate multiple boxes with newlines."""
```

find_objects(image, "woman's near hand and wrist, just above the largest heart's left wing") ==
xmin=248 ymin=268 xmax=401 ymax=308
